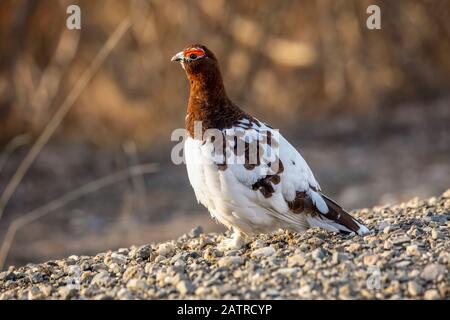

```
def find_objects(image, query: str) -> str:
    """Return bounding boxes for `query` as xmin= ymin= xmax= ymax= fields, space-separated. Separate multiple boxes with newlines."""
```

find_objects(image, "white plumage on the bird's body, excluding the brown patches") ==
xmin=184 ymin=118 xmax=368 ymax=247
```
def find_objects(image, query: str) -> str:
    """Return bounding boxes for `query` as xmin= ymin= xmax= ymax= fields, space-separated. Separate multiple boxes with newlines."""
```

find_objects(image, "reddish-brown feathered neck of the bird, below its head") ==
xmin=186 ymin=61 xmax=245 ymax=137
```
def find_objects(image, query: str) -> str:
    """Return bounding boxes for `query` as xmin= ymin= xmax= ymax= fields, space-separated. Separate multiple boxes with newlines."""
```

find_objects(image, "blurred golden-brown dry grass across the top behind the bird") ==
xmin=0 ymin=0 xmax=450 ymax=146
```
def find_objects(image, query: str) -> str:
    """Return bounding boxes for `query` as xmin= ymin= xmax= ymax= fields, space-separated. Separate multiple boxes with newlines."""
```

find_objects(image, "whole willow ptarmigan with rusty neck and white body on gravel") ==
xmin=172 ymin=44 xmax=369 ymax=249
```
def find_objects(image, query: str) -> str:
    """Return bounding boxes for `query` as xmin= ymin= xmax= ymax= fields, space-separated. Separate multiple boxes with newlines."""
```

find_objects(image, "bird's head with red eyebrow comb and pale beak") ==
xmin=171 ymin=44 xmax=218 ymax=75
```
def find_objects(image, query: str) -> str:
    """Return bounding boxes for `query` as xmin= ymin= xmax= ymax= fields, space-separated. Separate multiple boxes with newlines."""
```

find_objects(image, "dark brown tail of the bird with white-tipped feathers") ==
xmin=306 ymin=193 xmax=369 ymax=235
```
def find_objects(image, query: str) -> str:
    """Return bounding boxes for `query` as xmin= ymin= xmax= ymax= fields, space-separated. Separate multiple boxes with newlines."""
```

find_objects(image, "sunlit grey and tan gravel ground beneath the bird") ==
xmin=0 ymin=189 xmax=450 ymax=299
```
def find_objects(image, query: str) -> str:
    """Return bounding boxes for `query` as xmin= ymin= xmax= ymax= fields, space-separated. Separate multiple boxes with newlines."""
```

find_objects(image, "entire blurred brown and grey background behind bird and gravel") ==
xmin=0 ymin=0 xmax=450 ymax=266
